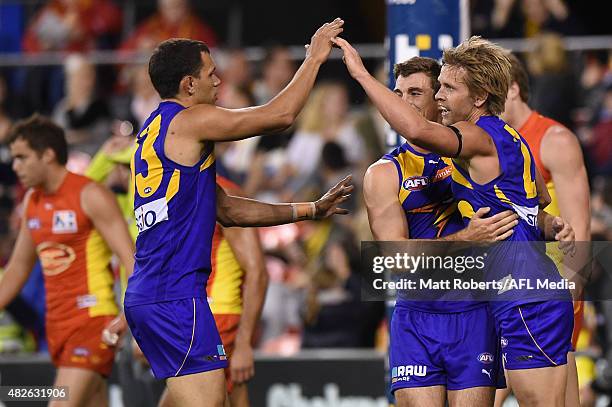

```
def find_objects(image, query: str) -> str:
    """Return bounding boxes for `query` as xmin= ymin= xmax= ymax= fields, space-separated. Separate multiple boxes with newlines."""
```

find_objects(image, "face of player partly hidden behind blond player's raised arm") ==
xmin=393 ymin=72 xmax=439 ymax=121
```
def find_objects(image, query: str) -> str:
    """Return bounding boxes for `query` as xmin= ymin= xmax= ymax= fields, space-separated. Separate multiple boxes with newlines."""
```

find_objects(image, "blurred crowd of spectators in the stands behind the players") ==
xmin=0 ymin=0 xmax=612 ymax=404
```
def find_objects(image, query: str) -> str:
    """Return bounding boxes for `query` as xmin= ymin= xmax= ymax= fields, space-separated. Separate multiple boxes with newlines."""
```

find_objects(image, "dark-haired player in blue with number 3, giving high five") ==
xmin=125 ymin=19 xmax=352 ymax=406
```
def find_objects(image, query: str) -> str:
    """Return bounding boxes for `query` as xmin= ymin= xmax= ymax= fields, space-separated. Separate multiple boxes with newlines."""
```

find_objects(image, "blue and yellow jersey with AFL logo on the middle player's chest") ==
xmin=382 ymin=143 xmax=485 ymax=313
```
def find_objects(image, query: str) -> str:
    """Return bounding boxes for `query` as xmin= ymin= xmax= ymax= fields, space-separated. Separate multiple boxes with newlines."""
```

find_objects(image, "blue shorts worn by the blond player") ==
xmin=496 ymin=301 xmax=574 ymax=370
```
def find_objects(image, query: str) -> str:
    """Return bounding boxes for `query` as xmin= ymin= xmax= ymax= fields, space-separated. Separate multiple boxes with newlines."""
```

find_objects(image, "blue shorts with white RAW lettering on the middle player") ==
xmin=389 ymin=306 xmax=506 ymax=392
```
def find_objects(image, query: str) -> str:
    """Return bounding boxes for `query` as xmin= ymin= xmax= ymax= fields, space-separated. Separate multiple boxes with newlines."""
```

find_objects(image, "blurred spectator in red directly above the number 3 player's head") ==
xmin=121 ymin=0 xmax=217 ymax=51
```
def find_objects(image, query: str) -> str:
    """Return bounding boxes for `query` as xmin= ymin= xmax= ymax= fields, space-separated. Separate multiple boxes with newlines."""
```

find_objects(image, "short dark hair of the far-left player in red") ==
xmin=8 ymin=113 xmax=68 ymax=165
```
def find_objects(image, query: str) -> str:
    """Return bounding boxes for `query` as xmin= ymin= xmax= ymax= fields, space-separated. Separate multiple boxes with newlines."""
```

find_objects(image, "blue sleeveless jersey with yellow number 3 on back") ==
xmin=125 ymin=102 xmax=216 ymax=306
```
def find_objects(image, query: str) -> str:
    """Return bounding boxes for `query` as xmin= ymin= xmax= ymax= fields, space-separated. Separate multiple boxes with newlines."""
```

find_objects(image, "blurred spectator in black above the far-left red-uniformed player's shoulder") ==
xmin=53 ymin=54 xmax=111 ymax=156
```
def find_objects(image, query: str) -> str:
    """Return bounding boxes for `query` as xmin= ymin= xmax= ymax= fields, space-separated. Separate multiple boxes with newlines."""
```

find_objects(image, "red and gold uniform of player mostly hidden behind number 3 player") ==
xmin=206 ymin=175 xmax=244 ymax=391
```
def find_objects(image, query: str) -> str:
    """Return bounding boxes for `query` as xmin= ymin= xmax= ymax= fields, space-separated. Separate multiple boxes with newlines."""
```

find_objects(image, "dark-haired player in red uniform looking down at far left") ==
xmin=0 ymin=115 xmax=134 ymax=406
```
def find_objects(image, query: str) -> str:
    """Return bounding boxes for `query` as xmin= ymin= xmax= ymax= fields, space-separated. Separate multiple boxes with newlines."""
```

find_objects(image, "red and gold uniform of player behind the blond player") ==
xmin=519 ymin=110 xmax=584 ymax=349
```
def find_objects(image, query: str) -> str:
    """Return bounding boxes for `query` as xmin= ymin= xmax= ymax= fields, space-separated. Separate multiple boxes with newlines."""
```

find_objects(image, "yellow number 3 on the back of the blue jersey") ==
xmin=132 ymin=115 xmax=164 ymax=198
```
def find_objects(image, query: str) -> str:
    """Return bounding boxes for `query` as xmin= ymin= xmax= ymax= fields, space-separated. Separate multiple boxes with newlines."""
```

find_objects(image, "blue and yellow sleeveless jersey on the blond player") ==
xmin=452 ymin=116 xmax=560 ymax=314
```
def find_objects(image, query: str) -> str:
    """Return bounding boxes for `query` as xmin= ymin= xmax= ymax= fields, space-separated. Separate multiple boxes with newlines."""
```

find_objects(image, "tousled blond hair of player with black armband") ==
xmin=442 ymin=36 xmax=512 ymax=115
